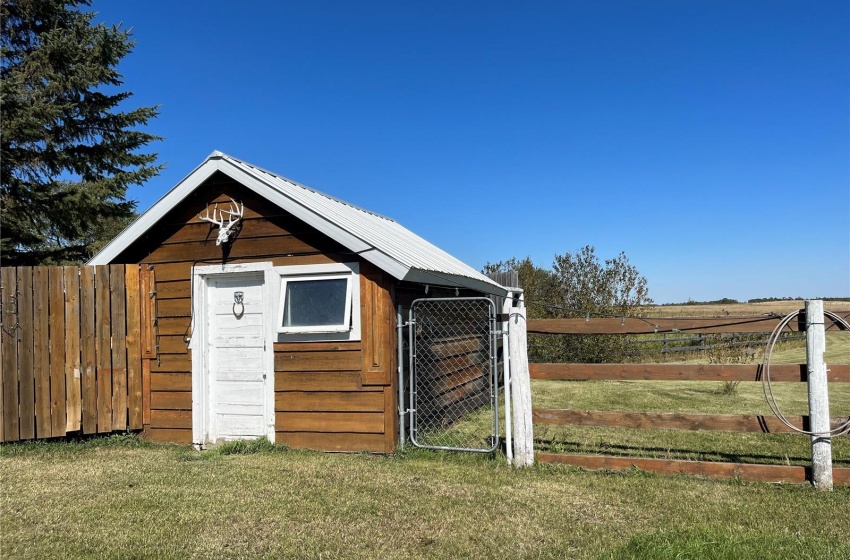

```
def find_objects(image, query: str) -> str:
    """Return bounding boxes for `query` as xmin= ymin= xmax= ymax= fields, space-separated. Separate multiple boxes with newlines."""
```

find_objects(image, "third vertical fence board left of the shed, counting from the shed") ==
xmin=95 ymin=265 xmax=112 ymax=433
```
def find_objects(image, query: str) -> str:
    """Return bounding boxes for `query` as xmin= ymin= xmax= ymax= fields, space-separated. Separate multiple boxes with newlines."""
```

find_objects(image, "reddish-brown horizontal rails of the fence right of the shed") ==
xmin=528 ymin=312 xmax=850 ymax=484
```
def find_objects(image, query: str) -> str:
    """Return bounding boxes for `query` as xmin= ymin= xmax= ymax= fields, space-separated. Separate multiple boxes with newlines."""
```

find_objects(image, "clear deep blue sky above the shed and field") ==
xmin=92 ymin=0 xmax=850 ymax=303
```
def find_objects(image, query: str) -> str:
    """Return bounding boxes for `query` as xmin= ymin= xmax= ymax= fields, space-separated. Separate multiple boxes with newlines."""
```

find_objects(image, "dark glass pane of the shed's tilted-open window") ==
xmin=281 ymin=278 xmax=348 ymax=328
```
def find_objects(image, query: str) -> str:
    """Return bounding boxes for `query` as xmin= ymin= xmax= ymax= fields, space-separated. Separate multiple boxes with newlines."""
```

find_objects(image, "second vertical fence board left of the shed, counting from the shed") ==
xmin=109 ymin=264 xmax=127 ymax=430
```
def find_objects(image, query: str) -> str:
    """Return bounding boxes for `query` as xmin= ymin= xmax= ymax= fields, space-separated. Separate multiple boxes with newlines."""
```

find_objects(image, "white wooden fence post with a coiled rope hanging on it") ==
xmin=806 ymin=300 xmax=832 ymax=490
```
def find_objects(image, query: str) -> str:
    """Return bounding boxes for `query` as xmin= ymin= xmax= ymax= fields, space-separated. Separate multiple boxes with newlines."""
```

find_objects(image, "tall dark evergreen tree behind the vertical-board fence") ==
xmin=0 ymin=0 xmax=161 ymax=266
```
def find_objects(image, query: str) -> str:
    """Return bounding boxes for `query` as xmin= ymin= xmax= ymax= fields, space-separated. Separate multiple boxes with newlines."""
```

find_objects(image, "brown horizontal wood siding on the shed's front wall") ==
xmin=116 ymin=173 xmax=398 ymax=452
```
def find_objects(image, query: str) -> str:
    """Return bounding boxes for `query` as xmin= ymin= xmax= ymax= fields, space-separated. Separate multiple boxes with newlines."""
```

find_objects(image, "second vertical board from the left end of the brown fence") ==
xmin=16 ymin=266 xmax=35 ymax=439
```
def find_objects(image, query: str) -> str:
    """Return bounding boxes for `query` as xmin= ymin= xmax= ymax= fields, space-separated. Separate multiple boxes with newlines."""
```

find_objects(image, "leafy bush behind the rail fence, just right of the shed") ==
xmin=484 ymin=245 xmax=652 ymax=363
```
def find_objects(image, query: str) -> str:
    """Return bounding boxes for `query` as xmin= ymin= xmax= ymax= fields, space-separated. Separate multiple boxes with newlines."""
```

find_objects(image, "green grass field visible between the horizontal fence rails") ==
xmin=532 ymin=332 xmax=850 ymax=467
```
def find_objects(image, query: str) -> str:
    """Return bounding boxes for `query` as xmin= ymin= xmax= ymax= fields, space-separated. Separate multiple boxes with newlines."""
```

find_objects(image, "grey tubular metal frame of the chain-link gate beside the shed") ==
xmin=398 ymin=296 xmax=496 ymax=453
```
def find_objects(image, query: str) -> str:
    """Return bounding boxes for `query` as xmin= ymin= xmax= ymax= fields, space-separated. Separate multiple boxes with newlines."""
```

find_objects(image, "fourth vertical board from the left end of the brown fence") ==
xmin=48 ymin=266 xmax=68 ymax=437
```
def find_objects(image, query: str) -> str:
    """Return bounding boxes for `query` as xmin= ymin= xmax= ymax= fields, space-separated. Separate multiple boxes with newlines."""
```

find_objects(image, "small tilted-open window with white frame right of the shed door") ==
xmin=277 ymin=265 xmax=359 ymax=338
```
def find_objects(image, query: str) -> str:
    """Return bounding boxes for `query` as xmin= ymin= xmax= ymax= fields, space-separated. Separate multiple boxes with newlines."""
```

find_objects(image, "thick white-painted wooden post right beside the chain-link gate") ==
xmin=508 ymin=294 xmax=534 ymax=467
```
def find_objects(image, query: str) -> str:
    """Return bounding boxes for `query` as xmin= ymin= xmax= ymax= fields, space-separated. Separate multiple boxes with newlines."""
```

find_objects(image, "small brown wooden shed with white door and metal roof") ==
xmin=89 ymin=152 xmax=505 ymax=452
